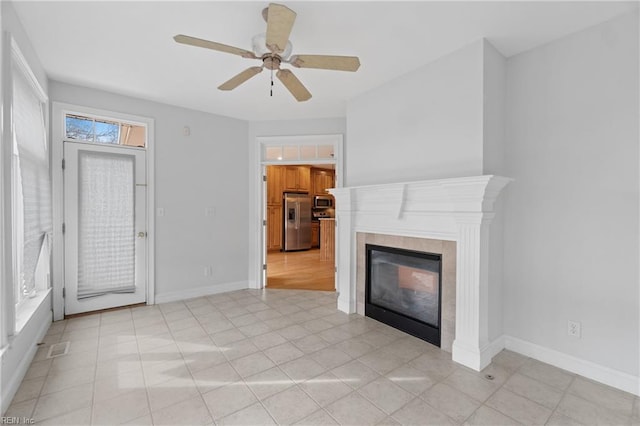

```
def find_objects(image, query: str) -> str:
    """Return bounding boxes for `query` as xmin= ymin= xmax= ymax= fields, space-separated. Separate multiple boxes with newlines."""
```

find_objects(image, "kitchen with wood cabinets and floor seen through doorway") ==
xmin=265 ymin=164 xmax=336 ymax=291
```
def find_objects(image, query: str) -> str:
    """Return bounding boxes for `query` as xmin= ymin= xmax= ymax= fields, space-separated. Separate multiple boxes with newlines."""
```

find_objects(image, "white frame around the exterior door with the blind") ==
xmin=51 ymin=102 xmax=155 ymax=321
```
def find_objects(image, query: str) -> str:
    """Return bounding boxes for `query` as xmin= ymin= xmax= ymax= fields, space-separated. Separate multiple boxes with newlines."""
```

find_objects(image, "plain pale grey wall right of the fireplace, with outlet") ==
xmin=504 ymin=13 xmax=640 ymax=376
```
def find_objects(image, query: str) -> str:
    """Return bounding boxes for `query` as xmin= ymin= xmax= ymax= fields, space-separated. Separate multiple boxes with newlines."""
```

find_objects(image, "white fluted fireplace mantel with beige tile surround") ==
xmin=330 ymin=175 xmax=511 ymax=371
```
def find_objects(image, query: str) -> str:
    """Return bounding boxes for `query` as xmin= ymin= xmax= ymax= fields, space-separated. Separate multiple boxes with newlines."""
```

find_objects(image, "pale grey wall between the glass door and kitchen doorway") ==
xmin=50 ymin=81 xmax=249 ymax=302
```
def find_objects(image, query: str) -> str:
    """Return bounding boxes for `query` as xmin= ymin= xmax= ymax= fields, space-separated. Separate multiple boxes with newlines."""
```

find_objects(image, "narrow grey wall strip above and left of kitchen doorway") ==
xmin=248 ymin=118 xmax=346 ymax=288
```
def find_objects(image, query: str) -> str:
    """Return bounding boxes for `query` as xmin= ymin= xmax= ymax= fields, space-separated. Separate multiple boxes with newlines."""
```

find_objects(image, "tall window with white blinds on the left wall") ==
xmin=11 ymin=41 xmax=52 ymax=306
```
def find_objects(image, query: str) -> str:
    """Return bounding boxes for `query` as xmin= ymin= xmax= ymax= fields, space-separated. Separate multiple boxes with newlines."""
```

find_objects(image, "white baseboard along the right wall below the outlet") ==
xmin=503 ymin=336 xmax=640 ymax=396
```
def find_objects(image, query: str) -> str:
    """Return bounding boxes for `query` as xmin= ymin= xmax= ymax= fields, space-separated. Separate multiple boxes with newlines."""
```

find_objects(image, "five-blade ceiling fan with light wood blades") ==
xmin=173 ymin=3 xmax=360 ymax=102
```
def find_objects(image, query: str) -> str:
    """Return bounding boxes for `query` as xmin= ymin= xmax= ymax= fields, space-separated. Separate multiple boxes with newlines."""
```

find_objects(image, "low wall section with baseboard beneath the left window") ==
xmin=2 ymin=298 xmax=53 ymax=414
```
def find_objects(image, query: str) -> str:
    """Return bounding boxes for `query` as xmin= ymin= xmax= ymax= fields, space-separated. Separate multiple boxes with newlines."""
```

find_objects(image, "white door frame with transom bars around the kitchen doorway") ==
xmin=251 ymin=134 xmax=344 ymax=289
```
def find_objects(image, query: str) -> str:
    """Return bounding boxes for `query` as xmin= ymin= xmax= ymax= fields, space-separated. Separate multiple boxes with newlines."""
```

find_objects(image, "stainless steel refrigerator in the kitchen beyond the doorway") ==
xmin=283 ymin=192 xmax=311 ymax=251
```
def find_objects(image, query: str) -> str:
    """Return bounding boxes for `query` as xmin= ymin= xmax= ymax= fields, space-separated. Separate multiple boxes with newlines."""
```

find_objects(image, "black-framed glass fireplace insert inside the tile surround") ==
xmin=365 ymin=244 xmax=442 ymax=346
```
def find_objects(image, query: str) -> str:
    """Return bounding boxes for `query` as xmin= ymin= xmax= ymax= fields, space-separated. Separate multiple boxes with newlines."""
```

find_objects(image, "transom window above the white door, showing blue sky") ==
xmin=64 ymin=114 xmax=146 ymax=148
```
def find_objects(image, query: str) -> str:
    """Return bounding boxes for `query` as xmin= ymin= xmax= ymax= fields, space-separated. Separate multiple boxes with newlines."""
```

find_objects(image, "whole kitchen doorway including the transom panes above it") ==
xmin=257 ymin=135 xmax=342 ymax=291
